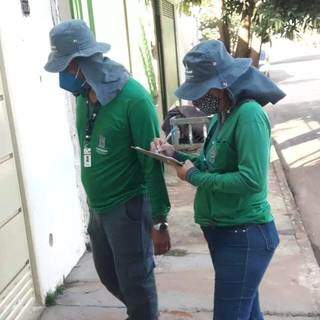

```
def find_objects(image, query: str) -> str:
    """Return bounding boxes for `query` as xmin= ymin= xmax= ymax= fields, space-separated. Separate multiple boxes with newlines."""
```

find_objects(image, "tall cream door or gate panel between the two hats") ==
xmin=154 ymin=0 xmax=179 ymax=116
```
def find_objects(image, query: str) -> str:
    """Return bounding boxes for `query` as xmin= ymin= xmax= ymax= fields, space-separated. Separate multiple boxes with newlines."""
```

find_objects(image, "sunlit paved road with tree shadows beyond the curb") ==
xmin=268 ymin=41 xmax=320 ymax=264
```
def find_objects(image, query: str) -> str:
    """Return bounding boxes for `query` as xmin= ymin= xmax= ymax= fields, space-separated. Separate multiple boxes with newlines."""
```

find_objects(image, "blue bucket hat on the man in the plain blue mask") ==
xmin=44 ymin=20 xmax=111 ymax=72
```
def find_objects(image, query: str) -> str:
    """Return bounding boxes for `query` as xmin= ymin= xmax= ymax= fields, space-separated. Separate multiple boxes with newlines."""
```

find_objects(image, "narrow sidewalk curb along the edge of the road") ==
xmin=271 ymin=141 xmax=320 ymax=316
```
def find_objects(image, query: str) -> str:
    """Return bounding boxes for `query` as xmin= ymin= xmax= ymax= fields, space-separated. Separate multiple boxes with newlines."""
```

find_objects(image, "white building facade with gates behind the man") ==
xmin=0 ymin=0 xmax=186 ymax=320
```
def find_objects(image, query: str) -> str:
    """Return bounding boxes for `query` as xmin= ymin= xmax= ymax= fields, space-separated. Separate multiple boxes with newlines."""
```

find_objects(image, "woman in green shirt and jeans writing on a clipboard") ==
xmin=151 ymin=40 xmax=285 ymax=320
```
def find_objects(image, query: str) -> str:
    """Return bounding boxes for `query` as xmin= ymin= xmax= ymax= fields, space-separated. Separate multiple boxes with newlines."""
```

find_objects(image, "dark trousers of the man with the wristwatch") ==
xmin=88 ymin=196 xmax=158 ymax=320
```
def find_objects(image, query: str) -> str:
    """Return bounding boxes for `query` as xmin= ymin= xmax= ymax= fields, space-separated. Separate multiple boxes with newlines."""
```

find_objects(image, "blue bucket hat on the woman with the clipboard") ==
xmin=175 ymin=40 xmax=252 ymax=100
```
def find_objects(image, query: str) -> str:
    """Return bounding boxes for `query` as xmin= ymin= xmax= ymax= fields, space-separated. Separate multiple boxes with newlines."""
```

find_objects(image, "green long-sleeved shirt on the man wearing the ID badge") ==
xmin=76 ymin=79 xmax=170 ymax=222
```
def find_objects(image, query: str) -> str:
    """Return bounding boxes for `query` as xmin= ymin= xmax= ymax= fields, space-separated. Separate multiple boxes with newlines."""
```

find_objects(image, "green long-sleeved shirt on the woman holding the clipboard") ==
xmin=177 ymin=100 xmax=273 ymax=226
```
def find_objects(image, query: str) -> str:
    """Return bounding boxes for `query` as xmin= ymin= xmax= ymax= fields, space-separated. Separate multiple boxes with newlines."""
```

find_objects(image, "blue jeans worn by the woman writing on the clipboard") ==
xmin=202 ymin=222 xmax=279 ymax=320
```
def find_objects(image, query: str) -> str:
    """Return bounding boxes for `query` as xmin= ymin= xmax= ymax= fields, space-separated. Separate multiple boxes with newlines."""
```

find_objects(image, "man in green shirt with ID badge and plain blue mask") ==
xmin=45 ymin=20 xmax=170 ymax=320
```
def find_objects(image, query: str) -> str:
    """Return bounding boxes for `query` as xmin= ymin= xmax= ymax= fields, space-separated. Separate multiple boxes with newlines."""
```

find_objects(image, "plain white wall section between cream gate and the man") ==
xmin=0 ymin=0 xmax=84 ymax=297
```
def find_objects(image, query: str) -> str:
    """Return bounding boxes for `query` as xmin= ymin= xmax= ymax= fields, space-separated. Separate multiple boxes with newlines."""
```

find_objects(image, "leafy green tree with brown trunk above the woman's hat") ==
xmin=180 ymin=0 xmax=320 ymax=66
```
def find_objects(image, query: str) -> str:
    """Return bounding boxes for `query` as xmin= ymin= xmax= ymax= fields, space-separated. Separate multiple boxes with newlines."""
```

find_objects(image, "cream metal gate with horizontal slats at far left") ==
xmin=0 ymin=64 xmax=35 ymax=320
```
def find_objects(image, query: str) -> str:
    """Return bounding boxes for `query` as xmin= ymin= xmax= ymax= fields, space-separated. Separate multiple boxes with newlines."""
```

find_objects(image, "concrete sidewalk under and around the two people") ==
xmin=41 ymin=148 xmax=320 ymax=320
